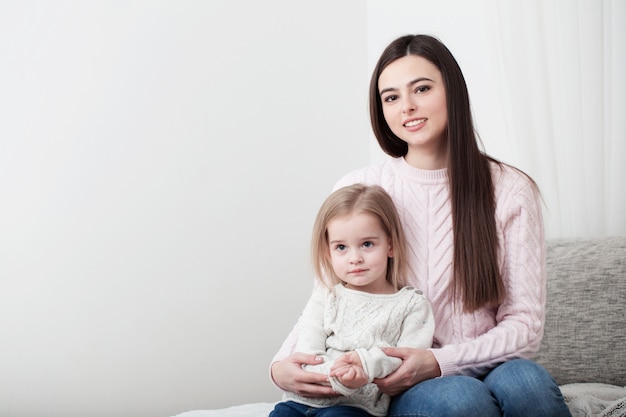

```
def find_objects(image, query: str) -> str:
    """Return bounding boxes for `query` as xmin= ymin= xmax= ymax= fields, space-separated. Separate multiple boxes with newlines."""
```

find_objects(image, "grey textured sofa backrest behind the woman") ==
xmin=534 ymin=236 xmax=626 ymax=386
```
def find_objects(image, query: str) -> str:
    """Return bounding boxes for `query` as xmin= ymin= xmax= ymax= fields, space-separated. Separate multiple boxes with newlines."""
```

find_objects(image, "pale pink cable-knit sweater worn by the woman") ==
xmin=273 ymin=158 xmax=546 ymax=376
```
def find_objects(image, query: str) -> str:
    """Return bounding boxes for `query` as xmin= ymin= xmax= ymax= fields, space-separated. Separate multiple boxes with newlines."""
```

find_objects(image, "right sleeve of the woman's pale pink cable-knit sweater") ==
xmin=432 ymin=168 xmax=546 ymax=376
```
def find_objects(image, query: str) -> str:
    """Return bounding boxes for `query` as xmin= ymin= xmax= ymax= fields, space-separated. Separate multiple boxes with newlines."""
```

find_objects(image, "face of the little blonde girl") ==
xmin=327 ymin=213 xmax=395 ymax=294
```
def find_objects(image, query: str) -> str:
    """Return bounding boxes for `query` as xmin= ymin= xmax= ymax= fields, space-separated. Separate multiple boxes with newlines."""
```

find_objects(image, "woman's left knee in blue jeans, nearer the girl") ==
xmin=388 ymin=376 xmax=500 ymax=417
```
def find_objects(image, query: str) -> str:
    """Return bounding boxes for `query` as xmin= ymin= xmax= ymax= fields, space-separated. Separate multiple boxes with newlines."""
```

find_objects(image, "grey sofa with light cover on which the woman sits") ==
xmin=171 ymin=236 xmax=626 ymax=417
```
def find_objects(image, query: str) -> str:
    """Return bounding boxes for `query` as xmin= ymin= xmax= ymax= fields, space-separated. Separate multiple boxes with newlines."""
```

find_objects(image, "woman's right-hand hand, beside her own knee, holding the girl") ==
xmin=374 ymin=348 xmax=441 ymax=396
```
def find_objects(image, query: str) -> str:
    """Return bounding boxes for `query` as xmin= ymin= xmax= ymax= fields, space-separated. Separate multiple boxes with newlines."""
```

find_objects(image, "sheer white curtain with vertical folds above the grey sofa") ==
xmin=483 ymin=0 xmax=626 ymax=237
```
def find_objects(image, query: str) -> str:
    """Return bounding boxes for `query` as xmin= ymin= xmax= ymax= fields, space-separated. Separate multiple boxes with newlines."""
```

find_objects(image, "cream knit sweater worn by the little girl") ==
xmin=284 ymin=285 xmax=435 ymax=416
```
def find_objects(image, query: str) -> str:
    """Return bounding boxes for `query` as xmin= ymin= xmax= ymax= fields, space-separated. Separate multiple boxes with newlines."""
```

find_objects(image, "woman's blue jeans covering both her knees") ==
xmin=388 ymin=359 xmax=571 ymax=417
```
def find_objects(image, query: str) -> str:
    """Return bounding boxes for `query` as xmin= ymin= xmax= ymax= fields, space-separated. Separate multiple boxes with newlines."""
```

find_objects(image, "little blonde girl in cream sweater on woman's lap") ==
xmin=270 ymin=184 xmax=434 ymax=417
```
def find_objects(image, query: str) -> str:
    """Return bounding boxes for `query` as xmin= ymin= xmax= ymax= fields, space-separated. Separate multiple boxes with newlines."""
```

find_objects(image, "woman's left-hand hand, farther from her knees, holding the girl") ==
xmin=271 ymin=352 xmax=339 ymax=397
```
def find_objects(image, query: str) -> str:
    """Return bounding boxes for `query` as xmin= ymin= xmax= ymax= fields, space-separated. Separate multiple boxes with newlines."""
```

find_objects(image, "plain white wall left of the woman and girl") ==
xmin=0 ymin=0 xmax=369 ymax=417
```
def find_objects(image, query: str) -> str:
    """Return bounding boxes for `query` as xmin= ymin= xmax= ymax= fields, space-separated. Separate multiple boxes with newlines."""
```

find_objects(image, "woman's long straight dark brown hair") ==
xmin=369 ymin=35 xmax=506 ymax=312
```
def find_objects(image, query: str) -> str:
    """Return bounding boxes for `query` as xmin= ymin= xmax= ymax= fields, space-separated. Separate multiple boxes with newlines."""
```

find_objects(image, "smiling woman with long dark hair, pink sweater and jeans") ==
xmin=271 ymin=35 xmax=570 ymax=417
